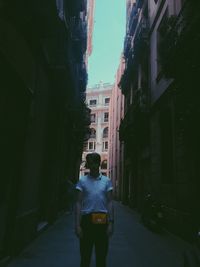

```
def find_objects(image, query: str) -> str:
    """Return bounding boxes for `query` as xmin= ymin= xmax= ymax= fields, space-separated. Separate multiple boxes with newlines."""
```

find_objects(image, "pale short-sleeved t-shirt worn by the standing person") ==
xmin=76 ymin=174 xmax=113 ymax=215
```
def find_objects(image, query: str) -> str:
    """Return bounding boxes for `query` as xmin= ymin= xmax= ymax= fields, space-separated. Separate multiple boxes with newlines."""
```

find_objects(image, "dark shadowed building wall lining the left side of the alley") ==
xmin=0 ymin=0 xmax=88 ymax=258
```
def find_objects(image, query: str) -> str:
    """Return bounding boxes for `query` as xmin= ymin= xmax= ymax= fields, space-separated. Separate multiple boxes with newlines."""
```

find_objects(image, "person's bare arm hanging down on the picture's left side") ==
xmin=75 ymin=190 xmax=83 ymax=238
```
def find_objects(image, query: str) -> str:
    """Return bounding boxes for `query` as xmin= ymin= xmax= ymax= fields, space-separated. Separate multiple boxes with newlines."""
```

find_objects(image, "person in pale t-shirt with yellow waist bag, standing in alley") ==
xmin=75 ymin=153 xmax=114 ymax=267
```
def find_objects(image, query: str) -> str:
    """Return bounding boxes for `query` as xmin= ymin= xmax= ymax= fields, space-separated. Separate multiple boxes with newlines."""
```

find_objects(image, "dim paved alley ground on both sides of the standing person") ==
xmin=5 ymin=202 xmax=189 ymax=267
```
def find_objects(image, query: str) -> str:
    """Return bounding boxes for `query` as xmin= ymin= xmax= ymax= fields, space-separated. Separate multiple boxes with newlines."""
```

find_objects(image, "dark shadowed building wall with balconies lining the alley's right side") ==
xmin=120 ymin=0 xmax=200 ymax=242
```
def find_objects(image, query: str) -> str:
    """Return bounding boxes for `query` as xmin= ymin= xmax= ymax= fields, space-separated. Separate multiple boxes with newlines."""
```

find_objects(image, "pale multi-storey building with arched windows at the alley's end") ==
xmin=80 ymin=82 xmax=113 ymax=178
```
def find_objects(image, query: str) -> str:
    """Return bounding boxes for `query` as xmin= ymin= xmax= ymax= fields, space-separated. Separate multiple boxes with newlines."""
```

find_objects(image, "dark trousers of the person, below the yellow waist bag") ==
xmin=80 ymin=215 xmax=108 ymax=267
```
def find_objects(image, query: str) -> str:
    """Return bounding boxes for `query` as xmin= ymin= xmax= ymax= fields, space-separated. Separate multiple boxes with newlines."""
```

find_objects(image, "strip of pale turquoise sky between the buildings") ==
xmin=88 ymin=0 xmax=126 ymax=87
